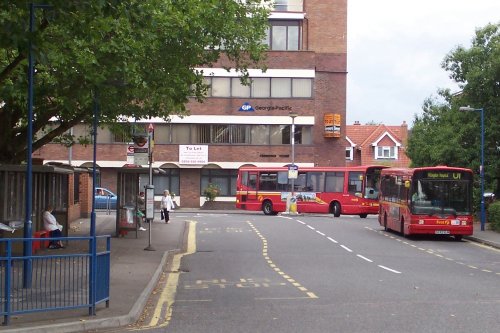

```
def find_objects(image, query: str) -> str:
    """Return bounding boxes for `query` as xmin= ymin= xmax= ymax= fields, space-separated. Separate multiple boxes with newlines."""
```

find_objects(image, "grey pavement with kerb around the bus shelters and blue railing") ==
xmin=1 ymin=209 xmax=500 ymax=333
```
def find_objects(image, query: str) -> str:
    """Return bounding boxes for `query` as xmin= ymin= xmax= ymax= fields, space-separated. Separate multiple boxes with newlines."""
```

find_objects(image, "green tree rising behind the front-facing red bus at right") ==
xmin=407 ymin=23 xmax=500 ymax=194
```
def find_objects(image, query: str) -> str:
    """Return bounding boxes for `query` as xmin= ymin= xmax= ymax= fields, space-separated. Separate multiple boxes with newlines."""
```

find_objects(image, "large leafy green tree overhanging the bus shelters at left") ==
xmin=0 ymin=0 xmax=269 ymax=163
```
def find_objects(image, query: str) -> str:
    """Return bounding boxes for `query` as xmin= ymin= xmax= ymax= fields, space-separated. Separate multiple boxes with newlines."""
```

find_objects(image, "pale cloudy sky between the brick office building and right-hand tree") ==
xmin=347 ymin=0 xmax=500 ymax=126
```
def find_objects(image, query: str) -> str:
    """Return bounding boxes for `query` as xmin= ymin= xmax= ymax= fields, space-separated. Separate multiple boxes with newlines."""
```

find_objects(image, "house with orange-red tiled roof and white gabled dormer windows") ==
xmin=346 ymin=121 xmax=410 ymax=167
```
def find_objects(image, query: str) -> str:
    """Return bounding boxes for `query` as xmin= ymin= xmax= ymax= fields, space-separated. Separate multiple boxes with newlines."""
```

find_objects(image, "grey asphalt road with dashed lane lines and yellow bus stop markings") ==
xmin=117 ymin=214 xmax=500 ymax=333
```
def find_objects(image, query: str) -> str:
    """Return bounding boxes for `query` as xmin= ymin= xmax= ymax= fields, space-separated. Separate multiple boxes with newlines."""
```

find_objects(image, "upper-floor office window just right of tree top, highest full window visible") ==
xmin=264 ymin=20 xmax=301 ymax=51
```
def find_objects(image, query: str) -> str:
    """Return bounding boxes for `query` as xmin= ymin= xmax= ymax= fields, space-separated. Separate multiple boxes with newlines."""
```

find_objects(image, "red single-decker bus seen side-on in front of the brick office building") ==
xmin=236 ymin=166 xmax=385 ymax=218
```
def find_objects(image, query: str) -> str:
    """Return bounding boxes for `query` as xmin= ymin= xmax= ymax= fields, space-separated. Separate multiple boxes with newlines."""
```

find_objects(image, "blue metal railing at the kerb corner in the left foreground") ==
xmin=0 ymin=235 xmax=111 ymax=325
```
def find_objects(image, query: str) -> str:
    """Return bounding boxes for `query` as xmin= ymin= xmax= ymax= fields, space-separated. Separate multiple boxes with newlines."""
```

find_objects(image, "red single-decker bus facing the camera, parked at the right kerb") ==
xmin=378 ymin=166 xmax=473 ymax=240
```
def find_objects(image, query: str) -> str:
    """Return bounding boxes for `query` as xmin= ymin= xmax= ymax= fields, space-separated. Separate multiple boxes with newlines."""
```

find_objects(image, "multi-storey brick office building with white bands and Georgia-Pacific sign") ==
xmin=34 ymin=0 xmax=347 ymax=207
